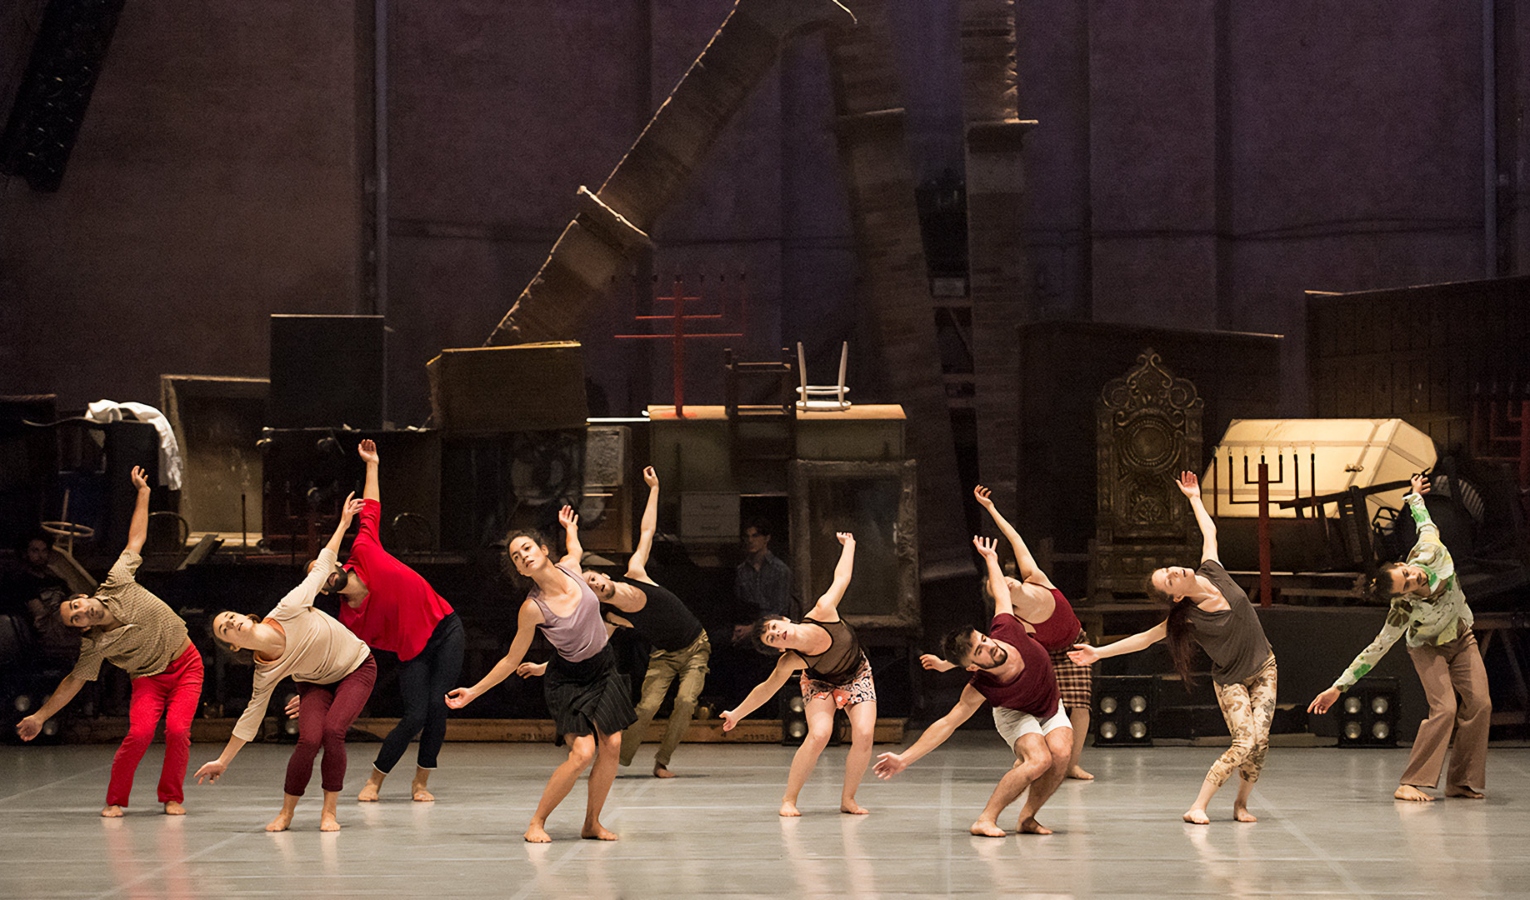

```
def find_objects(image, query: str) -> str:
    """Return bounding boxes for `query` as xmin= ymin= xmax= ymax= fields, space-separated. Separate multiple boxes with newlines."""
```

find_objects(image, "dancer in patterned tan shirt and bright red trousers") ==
xmin=15 ymin=465 xmax=202 ymax=819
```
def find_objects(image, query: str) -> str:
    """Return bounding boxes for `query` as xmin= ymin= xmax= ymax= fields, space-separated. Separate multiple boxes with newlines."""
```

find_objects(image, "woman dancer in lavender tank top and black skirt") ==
xmin=447 ymin=507 xmax=638 ymax=843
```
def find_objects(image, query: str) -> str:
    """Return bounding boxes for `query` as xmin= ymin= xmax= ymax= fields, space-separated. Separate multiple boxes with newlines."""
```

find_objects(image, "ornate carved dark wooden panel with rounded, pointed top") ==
xmin=1089 ymin=347 xmax=1206 ymax=600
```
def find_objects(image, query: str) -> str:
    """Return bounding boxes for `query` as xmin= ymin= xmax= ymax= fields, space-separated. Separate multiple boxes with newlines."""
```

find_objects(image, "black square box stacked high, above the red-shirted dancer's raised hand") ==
xmin=268 ymin=314 xmax=386 ymax=432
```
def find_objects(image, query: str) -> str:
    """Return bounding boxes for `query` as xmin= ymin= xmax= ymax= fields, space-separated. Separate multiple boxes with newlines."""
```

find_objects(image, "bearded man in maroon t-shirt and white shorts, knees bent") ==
xmin=877 ymin=537 xmax=1073 ymax=837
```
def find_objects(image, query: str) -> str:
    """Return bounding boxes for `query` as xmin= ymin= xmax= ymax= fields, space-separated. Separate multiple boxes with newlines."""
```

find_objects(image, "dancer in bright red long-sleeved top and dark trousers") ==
xmin=323 ymin=439 xmax=464 ymax=802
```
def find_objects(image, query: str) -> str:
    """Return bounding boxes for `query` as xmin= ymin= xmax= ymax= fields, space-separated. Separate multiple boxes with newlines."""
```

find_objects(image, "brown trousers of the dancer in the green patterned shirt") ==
xmin=1401 ymin=629 xmax=1493 ymax=791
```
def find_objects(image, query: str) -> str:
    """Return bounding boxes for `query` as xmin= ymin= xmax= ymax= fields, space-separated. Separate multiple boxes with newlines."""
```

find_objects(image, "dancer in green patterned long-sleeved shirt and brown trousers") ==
xmin=1307 ymin=474 xmax=1493 ymax=802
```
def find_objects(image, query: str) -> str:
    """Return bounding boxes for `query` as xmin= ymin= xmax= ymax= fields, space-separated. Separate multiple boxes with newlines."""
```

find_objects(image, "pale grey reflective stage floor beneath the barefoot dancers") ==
xmin=0 ymin=732 xmax=1530 ymax=900
